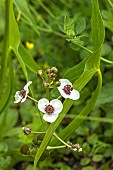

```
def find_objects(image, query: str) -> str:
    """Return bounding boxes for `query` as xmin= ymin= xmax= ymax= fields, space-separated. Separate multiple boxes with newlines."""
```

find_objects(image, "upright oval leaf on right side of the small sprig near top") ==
xmin=75 ymin=18 xmax=86 ymax=34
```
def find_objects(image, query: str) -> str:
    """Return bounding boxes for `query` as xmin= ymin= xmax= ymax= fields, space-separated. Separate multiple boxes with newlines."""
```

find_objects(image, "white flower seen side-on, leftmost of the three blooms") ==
xmin=14 ymin=81 xmax=32 ymax=103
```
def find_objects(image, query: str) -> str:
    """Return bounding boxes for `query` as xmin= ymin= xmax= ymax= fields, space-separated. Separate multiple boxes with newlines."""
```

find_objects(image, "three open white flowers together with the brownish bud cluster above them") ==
xmin=14 ymin=67 xmax=80 ymax=123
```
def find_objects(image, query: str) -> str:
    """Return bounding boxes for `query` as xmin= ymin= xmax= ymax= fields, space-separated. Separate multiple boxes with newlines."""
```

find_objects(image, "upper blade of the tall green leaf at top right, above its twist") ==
xmin=91 ymin=0 xmax=105 ymax=50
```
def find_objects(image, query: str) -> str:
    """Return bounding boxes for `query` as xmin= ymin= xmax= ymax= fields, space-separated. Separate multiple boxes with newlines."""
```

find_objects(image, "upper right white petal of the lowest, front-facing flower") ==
xmin=50 ymin=99 xmax=63 ymax=114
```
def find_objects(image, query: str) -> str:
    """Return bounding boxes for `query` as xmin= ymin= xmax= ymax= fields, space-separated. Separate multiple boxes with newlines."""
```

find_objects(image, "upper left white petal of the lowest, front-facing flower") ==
xmin=38 ymin=98 xmax=49 ymax=113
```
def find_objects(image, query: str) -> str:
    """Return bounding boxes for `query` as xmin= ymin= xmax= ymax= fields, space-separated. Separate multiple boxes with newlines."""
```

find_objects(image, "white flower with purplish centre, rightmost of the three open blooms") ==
xmin=57 ymin=79 xmax=80 ymax=100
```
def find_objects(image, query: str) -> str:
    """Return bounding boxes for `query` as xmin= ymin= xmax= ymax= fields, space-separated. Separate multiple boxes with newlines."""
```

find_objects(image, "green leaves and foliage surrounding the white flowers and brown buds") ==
xmin=0 ymin=0 xmax=113 ymax=170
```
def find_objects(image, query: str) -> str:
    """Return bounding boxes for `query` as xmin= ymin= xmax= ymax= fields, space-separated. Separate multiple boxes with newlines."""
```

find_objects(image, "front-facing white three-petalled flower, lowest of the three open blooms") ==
xmin=38 ymin=98 xmax=63 ymax=123
